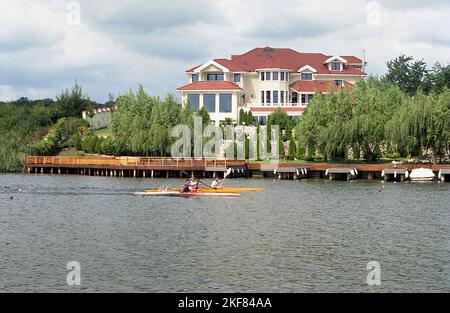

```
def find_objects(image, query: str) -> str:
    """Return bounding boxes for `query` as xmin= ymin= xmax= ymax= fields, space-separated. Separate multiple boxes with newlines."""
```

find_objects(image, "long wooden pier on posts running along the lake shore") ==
xmin=26 ymin=156 xmax=450 ymax=181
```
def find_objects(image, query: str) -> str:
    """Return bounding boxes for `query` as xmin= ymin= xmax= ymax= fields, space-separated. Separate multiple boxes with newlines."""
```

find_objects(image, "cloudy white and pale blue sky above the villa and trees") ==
xmin=0 ymin=0 xmax=450 ymax=102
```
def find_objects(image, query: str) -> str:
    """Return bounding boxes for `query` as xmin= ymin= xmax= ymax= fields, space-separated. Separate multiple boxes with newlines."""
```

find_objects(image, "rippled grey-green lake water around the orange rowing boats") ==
xmin=0 ymin=175 xmax=450 ymax=292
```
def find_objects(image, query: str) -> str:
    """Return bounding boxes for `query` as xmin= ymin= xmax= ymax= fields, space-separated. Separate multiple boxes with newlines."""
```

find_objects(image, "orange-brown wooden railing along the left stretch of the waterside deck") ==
xmin=26 ymin=156 xmax=246 ymax=168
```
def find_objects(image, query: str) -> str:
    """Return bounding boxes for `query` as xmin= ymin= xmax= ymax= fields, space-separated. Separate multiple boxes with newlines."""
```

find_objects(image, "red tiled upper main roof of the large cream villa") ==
xmin=187 ymin=48 xmax=365 ymax=75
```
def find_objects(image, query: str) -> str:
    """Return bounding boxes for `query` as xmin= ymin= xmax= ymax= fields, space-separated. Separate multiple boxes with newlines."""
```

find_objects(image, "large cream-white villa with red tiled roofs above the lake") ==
xmin=177 ymin=47 xmax=366 ymax=125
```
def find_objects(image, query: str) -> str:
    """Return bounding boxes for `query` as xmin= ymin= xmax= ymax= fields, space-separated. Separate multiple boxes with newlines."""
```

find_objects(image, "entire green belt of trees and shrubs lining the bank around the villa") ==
xmin=0 ymin=55 xmax=450 ymax=171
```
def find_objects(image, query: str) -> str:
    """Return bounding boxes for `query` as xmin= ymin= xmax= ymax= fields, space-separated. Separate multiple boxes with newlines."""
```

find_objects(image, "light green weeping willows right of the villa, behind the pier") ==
xmin=295 ymin=77 xmax=450 ymax=161
